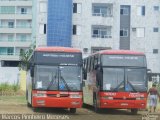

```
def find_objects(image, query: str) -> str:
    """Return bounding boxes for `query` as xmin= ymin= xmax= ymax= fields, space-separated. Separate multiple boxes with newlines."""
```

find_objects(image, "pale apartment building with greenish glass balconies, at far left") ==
xmin=0 ymin=0 xmax=34 ymax=67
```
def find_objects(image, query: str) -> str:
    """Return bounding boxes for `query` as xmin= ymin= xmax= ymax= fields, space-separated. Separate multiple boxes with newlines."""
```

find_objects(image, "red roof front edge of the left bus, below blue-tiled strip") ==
xmin=35 ymin=47 xmax=81 ymax=53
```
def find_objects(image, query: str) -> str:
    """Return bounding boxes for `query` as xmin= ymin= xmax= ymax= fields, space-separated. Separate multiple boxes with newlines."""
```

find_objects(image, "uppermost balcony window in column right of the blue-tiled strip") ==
xmin=92 ymin=4 xmax=112 ymax=17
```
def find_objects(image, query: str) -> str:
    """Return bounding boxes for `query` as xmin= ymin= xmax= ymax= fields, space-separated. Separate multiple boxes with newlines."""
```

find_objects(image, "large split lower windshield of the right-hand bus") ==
xmin=102 ymin=68 xmax=147 ymax=92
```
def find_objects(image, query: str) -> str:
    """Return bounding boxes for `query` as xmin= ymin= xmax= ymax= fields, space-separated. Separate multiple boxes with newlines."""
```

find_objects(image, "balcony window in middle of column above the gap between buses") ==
xmin=92 ymin=26 xmax=112 ymax=38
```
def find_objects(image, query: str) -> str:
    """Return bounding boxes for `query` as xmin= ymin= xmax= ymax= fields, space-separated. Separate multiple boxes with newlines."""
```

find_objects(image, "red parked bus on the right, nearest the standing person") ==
xmin=83 ymin=50 xmax=148 ymax=114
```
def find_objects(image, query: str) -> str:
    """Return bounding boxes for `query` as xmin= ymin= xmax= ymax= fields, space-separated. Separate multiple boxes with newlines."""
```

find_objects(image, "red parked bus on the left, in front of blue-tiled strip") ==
xmin=26 ymin=47 xmax=83 ymax=113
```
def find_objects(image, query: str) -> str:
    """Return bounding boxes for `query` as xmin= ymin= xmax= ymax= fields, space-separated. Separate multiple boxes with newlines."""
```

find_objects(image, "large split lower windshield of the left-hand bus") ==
xmin=34 ymin=65 xmax=81 ymax=91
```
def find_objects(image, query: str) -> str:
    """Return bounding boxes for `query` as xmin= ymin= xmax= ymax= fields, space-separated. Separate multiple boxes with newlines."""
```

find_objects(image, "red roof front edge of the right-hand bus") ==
xmin=95 ymin=50 xmax=145 ymax=55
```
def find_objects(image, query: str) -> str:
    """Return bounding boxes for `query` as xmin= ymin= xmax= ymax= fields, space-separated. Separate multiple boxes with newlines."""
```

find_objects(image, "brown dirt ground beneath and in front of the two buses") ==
xmin=0 ymin=104 xmax=160 ymax=120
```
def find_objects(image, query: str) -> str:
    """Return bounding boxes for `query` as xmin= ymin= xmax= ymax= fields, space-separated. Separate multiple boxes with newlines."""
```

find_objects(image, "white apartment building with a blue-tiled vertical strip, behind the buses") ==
xmin=36 ymin=0 xmax=160 ymax=81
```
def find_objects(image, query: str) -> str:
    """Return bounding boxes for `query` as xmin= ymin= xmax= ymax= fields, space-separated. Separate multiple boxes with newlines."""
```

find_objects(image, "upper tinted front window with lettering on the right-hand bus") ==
xmin=102 ymin=55 xmax=146 ymax=67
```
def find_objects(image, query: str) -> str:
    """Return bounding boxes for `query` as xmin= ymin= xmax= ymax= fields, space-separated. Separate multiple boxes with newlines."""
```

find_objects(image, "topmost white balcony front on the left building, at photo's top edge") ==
xmin=0 ymin=0 xmax=32 ymax=6
